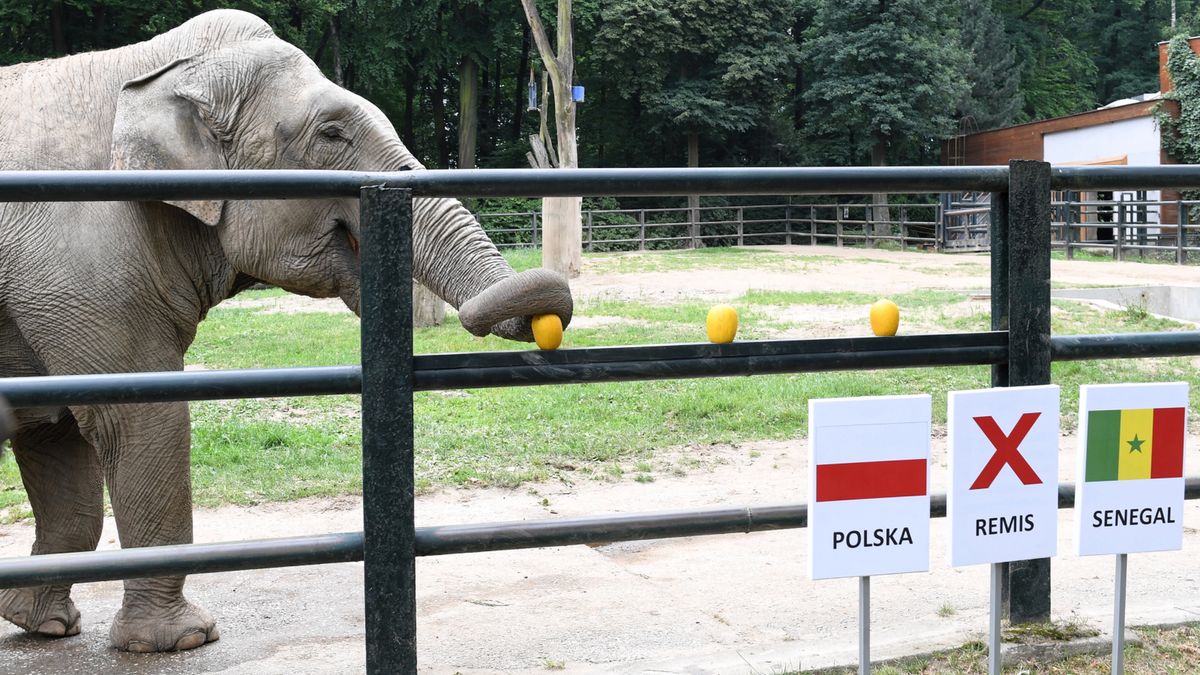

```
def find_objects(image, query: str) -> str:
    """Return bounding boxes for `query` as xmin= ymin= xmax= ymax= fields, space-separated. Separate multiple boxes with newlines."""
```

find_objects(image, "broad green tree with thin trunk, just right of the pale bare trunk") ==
xmin=594 ymin=0 xmax=798 ymax=237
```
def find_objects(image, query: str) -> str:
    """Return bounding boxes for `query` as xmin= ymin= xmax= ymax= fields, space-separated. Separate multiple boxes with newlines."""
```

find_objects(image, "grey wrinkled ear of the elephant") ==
xmin=113 ymin=58 xmax=236 ymax=226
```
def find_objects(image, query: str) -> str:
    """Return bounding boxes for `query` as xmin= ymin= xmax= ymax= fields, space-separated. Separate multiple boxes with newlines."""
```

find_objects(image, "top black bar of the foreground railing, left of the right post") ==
xmin=0 ymin=167 xmax=1008 ymax=202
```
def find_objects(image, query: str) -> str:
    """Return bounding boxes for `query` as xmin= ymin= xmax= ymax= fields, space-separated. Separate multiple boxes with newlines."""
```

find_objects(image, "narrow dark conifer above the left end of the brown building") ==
xmin=959 ymin=0 xmax=1025 ymax=130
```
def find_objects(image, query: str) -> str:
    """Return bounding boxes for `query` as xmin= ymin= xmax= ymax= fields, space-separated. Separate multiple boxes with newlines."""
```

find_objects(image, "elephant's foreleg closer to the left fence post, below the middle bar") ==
xmin=78 ymin=404 xmax=218 ymax=652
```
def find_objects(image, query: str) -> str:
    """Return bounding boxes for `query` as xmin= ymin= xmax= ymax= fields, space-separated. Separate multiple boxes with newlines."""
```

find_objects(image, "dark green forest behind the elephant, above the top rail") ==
xmin=0 ymin=0 xmax=1200 ymax=183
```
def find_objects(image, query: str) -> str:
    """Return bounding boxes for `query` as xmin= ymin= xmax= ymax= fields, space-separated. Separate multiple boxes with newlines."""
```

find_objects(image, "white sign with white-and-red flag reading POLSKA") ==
xmin=808 ymin=394 xmax=931 ymax=579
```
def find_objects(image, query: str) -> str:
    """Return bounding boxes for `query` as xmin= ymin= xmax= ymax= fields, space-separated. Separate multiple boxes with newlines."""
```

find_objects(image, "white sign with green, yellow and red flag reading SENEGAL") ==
xmin=1075 ymin=382 xmax=1188 ymax=555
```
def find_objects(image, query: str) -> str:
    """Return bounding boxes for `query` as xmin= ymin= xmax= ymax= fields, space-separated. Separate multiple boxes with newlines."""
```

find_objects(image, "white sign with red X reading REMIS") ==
xmin=946 ymin=384 xmax=1058 ymax=567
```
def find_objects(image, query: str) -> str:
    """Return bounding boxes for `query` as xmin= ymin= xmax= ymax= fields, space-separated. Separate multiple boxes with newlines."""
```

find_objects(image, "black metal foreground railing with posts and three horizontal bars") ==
xmin=0 ymin=161 xmax=1200 ymax=673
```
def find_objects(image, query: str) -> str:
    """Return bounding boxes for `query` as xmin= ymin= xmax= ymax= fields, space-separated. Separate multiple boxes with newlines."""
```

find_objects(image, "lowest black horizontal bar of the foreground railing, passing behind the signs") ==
xmin=0 ymin=478 xmax=1200 ymax=589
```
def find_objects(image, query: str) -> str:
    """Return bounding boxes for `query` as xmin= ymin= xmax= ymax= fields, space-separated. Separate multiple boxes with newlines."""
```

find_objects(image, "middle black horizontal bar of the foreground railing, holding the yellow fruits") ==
xmin=0 ymin=331 xmax=1200 ymax=407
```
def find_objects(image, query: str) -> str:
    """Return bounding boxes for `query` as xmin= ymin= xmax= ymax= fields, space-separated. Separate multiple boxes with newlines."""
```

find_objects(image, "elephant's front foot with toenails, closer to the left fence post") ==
xmin=108 ymin=598 xmax=221 ymax=653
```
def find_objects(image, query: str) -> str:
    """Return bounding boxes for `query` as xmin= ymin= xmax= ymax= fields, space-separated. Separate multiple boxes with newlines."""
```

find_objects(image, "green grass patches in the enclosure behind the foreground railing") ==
xmin=0 ymin=249 xmax=1200 ymax=514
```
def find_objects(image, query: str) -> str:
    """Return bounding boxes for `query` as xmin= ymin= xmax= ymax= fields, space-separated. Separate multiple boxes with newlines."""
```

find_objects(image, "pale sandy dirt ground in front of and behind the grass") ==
xmin=0 ymin=246 xmax=1200 ymax=675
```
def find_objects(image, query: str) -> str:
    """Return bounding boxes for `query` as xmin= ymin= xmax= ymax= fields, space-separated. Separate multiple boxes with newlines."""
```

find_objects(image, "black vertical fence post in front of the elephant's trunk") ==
xmin=359 ymin=187 xmax=416 ymax=675
